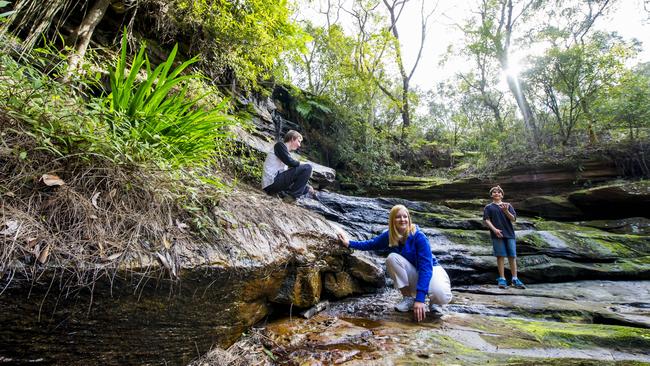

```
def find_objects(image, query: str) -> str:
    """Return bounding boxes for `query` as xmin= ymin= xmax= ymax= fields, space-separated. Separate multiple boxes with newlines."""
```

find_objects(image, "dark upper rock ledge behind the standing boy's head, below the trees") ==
xmin=372 ymin=160 xmax=650 ymax=221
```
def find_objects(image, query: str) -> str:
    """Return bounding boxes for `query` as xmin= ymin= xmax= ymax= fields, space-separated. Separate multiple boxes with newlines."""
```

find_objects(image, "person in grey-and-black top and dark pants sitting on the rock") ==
xmin=262 ymin=130 xmax=314 ymax=203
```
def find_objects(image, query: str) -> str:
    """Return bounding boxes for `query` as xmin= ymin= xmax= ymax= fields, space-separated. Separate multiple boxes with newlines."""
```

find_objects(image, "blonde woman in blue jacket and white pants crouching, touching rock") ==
xmin=338 ymin=205 xmax=452 ymax=322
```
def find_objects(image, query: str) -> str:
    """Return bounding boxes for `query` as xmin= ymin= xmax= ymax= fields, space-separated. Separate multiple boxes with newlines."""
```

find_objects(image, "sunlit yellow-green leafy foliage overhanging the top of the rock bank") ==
xmin=165 ymin=0 xmax=305 ymax=87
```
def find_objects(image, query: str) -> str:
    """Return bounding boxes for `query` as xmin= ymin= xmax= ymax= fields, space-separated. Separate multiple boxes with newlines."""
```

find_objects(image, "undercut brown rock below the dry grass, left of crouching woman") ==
xmin=0 ymin=190 xmax=384 ymax=364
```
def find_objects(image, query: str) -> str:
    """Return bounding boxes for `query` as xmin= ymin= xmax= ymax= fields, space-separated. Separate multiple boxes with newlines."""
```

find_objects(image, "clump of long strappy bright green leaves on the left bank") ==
xmin=105 ymin=33 xmax=235 ymax=167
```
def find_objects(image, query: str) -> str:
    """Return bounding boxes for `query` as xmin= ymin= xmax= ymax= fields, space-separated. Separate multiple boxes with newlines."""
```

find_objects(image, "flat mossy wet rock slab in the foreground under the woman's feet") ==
xmin=234 ymin=281 xmax=650 ymax=365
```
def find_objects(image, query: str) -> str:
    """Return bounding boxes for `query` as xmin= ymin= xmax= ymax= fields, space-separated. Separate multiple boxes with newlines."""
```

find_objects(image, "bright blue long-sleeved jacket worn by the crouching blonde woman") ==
xmin=350 ymin=228 xmax=439 ymax=302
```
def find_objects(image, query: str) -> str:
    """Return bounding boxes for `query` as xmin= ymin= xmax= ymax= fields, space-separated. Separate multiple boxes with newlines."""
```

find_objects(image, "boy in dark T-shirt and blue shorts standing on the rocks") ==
xmin=483 ymin=186 xmax=526 ymax=289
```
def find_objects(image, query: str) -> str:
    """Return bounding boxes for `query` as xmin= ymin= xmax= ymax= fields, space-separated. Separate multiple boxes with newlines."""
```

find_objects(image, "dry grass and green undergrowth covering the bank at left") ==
xmin=0 ymin=31 xmax=246 ymax=292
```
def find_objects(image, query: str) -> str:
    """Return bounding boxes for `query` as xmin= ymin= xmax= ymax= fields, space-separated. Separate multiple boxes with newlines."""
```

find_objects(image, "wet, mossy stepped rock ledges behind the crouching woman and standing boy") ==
xmin=299 ymin=192 xmax=650 ymax=285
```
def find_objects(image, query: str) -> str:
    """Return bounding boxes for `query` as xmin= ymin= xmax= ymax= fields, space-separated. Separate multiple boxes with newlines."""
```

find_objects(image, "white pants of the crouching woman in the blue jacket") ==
xmin=386 ymin=253 xmax=452 ymax=305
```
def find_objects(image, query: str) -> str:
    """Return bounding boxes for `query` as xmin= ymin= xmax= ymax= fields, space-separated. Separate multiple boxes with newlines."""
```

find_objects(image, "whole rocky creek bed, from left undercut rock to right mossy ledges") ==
xmin=0 ymin=184 xmax=650 ymax=365
